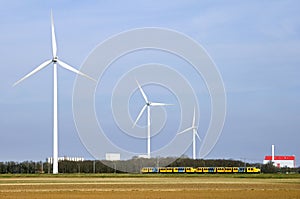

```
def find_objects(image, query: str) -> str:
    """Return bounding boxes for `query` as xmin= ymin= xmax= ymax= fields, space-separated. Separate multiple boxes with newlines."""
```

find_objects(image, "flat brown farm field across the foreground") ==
xmin=0 ymin=177 xmax=300 ymax=199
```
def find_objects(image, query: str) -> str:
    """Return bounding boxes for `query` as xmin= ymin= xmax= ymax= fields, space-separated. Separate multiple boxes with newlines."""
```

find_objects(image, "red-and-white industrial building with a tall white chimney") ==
xmin=263 ymin=145 xmax=296 ymax=168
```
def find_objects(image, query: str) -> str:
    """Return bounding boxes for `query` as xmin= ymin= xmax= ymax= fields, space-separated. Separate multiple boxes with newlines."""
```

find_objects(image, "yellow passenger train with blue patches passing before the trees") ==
xmin=141 ymin=167 xmax=260 ymax=174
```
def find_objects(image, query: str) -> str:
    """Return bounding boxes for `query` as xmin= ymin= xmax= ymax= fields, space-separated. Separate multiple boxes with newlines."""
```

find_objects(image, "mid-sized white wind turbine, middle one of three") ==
xmin=132 ymin=80 xmax=172 ymax=158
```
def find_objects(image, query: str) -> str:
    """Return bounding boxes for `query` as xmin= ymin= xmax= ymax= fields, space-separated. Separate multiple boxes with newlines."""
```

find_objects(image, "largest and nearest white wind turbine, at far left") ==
xmin=13 ymin=11 xmax=96 ymax=174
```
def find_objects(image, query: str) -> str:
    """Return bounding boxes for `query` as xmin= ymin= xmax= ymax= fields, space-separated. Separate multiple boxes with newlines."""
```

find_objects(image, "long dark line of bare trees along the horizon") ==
xmin=0 ymin=157 xmax=300 ymax=174
